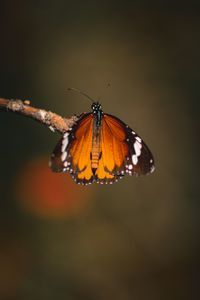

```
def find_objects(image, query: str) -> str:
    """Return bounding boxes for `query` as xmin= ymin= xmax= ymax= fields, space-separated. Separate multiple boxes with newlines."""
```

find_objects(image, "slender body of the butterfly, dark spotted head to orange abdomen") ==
xmin=91 ymin=102 xmax=103 ymax=173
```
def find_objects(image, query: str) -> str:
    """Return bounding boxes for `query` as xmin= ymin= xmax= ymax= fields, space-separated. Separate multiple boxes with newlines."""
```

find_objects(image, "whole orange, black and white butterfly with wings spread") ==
xmin=50 ymin=89 xmax=154 ymax=185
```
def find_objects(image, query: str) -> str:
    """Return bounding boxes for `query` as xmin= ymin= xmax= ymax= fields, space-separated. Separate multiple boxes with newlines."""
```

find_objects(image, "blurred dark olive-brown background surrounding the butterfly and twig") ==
xmin=0 ymin=0 xmax=200 ymax=300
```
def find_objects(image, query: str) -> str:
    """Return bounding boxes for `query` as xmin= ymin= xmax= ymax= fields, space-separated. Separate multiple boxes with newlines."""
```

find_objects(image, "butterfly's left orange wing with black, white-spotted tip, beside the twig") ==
xmin=50 ymin=113 xmax=93 ymax=184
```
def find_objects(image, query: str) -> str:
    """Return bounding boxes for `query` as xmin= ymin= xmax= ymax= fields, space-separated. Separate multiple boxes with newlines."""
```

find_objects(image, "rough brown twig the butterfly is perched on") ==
xmin=0 ymin=98 xmax=78 ymax=133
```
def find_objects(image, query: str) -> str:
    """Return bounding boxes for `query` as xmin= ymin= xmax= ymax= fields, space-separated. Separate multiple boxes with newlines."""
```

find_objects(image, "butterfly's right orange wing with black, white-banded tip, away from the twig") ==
xmin=98 ymin=114 xmax=154 ymax=181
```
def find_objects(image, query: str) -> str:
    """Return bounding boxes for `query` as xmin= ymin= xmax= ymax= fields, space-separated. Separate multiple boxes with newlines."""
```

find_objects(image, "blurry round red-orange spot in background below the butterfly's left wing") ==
xmin=16 ymin=158 xmax=91 ymax=218
